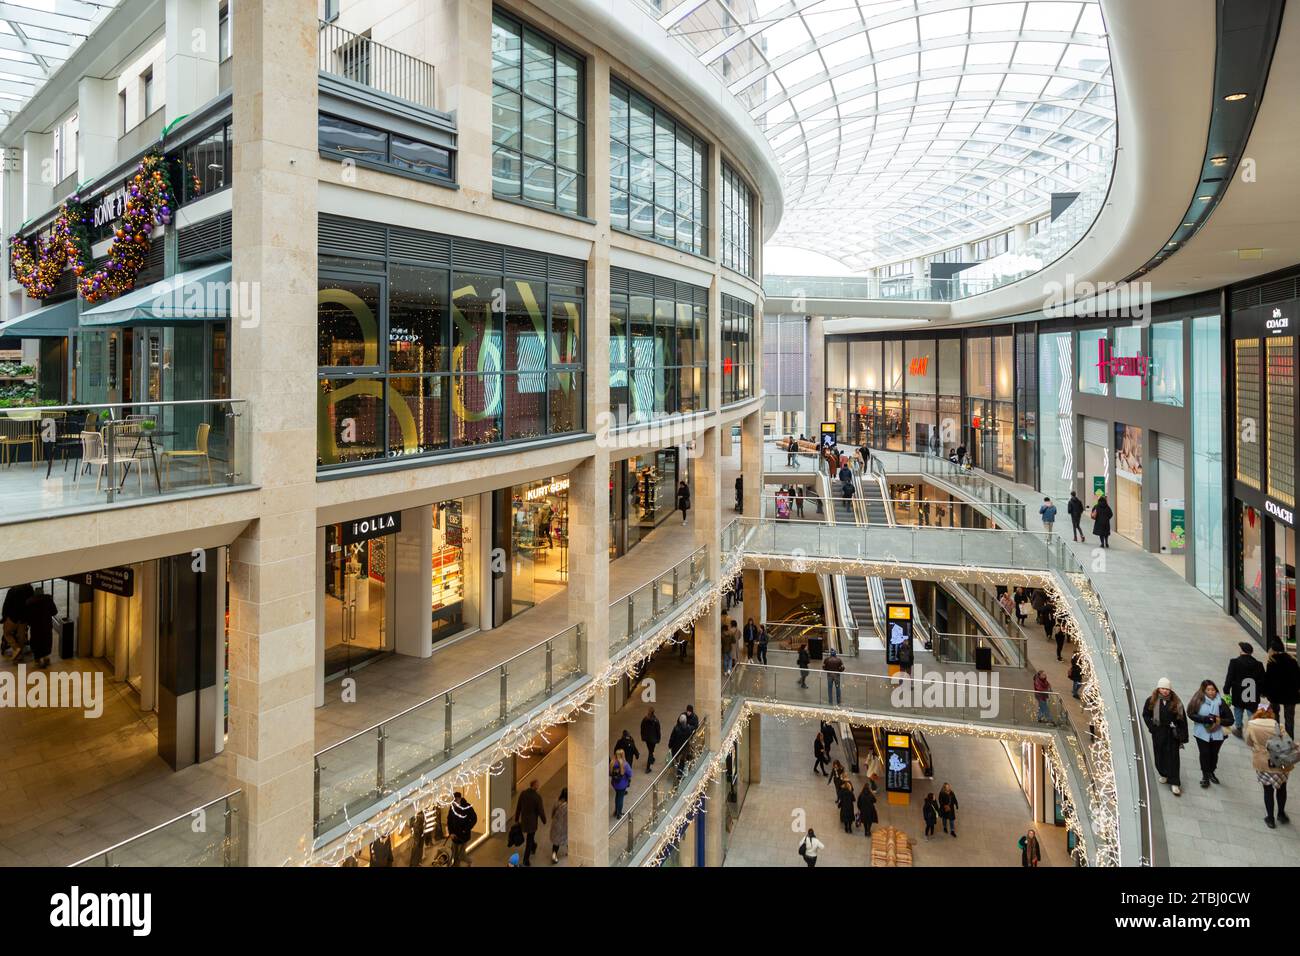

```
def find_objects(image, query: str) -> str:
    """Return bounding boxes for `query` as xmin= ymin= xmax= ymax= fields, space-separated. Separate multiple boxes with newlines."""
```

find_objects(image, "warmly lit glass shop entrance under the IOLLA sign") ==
xmin=325 ymin=522 xmax=394 ymax=680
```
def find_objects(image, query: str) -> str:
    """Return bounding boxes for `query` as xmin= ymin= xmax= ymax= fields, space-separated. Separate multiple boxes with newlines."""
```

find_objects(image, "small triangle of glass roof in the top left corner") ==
xmin=0 ymin=0 xmax=117 ymax=127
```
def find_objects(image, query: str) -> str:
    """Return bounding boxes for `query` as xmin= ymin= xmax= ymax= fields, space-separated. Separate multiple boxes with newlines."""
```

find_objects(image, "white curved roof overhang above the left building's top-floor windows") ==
xmin=533 ymin=0 xmax=785 ymax=241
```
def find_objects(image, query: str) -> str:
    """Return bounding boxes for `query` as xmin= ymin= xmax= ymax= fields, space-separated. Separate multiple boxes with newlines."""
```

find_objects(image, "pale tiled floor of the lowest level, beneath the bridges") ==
xmin=724 ymin=715 xmax=1070 ymax=866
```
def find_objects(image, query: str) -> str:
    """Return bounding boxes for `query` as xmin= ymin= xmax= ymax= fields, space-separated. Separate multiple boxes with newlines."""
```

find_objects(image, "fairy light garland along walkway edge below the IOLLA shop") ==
xmin=304 ymin=542 xmax=744 ymax=866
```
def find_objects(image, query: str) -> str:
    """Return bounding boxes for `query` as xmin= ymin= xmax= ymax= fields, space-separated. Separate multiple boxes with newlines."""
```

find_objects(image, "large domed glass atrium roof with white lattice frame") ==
xmin=641 ymin=0 xmax=1115 ymax=271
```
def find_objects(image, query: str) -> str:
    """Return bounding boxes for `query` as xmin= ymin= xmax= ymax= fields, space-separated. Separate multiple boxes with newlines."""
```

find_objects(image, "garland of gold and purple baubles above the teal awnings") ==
xmin=9 ymin=152 xmax=172 ymax=302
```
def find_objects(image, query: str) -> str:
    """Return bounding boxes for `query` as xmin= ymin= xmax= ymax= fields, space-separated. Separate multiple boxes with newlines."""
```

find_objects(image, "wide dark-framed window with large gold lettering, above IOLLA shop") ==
xmin=317 ymin=237 xmax=584 ymax=466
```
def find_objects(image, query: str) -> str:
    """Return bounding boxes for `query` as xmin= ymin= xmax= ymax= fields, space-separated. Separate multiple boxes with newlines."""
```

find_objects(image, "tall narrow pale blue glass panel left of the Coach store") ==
xmin=1192 ymin=315 xmax=1225 ymax=605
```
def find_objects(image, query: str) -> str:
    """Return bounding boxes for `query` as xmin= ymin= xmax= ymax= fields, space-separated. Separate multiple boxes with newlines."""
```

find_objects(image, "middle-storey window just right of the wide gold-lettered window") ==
xmin=610 ymin=269 xmax=712 ymax=423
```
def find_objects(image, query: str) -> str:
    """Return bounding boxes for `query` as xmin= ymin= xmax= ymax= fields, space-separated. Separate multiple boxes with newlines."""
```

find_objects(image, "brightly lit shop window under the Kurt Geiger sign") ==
xmin=510 ymin=475 xmax=568 ymax=615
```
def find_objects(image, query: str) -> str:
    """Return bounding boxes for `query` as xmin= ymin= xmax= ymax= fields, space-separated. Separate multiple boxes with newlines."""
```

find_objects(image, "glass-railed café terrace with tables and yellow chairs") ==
xmin=0 ymin=399 xmax=252 ymax=524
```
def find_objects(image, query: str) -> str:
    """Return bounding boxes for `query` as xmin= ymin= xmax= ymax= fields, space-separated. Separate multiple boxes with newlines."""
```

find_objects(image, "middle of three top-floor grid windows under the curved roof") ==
xmin=610 ymin=79 xmax=709 ymax=255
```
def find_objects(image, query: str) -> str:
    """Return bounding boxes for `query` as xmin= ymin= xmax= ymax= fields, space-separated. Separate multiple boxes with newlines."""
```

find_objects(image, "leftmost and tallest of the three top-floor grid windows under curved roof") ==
xmin=491 ymin=10 xmax=586 ymax=215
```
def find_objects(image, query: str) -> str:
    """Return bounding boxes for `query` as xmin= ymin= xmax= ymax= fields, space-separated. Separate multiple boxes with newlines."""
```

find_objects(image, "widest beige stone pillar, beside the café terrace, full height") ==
xmin=224 ymin=0 xmax=321 ymax=865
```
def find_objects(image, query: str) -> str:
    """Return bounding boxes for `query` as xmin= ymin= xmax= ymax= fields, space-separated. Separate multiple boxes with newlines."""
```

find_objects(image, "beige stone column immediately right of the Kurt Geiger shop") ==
xmin=568 ymin=48 xmax=611 ymax=866
